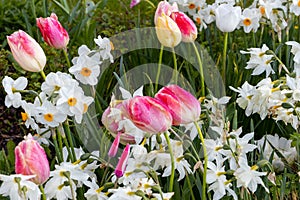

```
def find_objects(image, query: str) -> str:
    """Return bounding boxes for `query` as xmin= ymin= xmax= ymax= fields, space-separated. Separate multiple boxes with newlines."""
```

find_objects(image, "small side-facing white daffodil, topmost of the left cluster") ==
xmin=94 ymin=35 xmax=114 ymax=63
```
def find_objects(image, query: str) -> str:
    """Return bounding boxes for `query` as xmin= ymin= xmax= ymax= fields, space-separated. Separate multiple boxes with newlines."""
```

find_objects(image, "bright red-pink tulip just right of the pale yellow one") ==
xmin=171 ymin=12 xmax=198 ymax=42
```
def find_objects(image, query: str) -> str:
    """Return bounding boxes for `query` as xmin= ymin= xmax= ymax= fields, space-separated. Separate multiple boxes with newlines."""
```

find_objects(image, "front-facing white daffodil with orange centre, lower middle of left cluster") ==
xmin=36 ymin=100 xmax=67 ymax=127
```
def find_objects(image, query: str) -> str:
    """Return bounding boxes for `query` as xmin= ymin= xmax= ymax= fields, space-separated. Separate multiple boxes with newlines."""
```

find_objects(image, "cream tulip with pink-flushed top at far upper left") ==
xmin=7 ymin=30 xmax=46 ymax=72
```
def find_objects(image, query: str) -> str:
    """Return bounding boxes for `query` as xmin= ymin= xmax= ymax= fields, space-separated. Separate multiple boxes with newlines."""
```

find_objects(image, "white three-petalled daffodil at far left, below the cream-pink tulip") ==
xmin=2 ymin=76 xmax=28 ymax=108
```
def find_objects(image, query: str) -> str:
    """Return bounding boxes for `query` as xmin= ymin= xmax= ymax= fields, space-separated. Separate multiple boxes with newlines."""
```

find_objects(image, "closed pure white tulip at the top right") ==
xmin=215 ymin=4 xmax=242 ymax=32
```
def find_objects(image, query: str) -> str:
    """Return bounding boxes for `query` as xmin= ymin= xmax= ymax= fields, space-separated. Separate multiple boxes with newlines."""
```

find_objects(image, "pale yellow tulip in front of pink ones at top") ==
xmin=155 ymin=14 xmax=181 ymax=47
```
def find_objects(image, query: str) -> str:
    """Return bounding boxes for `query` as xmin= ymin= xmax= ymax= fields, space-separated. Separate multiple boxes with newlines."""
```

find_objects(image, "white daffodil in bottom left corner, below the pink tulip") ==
xmin=0 ymin=174 xmax=41 ymax=200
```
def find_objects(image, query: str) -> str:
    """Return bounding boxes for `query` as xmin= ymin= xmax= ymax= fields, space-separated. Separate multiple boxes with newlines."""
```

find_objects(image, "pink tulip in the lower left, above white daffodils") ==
xmin=15 ymin=135 xmax=50 ymax=184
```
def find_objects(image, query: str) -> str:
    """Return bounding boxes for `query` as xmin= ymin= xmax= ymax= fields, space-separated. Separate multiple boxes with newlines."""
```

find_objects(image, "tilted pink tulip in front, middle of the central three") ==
xmin=124 ymin=96 xmax=172 ymax=134
